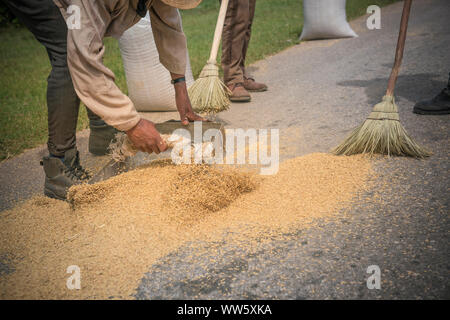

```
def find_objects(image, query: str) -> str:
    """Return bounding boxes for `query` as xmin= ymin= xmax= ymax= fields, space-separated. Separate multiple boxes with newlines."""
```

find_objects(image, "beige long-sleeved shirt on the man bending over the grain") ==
xmin=53 ymin=0 xmax=187 ymax=131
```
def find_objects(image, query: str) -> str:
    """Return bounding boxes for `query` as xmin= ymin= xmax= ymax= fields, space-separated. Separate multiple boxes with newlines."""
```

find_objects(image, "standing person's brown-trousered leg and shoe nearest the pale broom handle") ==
xmin=222 ymin=0 xmax=251 ymax=102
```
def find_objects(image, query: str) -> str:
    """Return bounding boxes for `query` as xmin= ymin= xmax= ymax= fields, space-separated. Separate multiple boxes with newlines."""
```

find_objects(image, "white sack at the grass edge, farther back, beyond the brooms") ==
xmin=300 ymin=0 xmax=358 ymax=40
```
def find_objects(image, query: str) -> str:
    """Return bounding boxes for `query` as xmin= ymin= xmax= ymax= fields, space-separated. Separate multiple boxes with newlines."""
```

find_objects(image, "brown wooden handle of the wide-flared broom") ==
xmin=386 ymin=0 xmax=412 ymax=96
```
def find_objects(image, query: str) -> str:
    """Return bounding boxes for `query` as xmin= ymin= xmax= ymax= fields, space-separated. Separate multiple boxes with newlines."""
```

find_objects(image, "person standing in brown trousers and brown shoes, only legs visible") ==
xmin=222 ymin=0 xmax=267 ymax=102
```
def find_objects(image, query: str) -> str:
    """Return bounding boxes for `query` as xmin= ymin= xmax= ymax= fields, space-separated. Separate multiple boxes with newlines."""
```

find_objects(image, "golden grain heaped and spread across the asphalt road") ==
xmin=0 ymin=154 xmax=372 ymax=299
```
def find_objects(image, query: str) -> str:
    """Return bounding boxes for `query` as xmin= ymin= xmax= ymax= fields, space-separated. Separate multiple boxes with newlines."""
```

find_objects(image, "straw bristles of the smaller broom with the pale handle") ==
xmin=188 ymin=62 xmax=231 ymax=113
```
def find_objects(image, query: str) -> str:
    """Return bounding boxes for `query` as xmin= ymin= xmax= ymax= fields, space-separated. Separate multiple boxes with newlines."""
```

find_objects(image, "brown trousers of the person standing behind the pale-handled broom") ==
xmin=222 ymin=0 xmax=256 ymax=85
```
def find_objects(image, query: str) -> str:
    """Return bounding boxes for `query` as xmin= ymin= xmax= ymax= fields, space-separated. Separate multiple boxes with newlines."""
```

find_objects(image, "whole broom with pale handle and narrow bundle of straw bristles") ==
xmin=188 ymin=0 xmax=231 ymax=113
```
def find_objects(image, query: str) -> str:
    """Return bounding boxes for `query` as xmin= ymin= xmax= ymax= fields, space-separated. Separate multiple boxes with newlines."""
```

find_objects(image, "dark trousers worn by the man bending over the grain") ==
xmin=5 ymin=0 xmax=102 ymax=157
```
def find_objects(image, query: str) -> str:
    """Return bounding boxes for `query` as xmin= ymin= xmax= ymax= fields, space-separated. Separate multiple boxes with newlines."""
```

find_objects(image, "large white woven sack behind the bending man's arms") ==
xmin=119 ymin=13 xmax=194 ymax=111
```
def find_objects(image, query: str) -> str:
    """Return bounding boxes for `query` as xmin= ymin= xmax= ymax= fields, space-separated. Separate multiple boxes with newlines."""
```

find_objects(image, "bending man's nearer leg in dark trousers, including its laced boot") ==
xmin=6 ymin=0 xmax=89 ymax=200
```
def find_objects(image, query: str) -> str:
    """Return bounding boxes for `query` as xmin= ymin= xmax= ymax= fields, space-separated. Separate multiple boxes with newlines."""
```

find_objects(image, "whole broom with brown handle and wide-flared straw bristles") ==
xmin=332 ymin=0 xmax=431 ymax=158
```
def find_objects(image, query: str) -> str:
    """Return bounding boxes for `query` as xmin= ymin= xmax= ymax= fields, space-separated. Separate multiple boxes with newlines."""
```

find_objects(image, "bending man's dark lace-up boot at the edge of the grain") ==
xmin=41 ymin=148 xmax=90 ymax=200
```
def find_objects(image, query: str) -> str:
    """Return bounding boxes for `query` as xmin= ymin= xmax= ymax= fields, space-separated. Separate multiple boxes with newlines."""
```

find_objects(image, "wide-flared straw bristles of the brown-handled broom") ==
xmin=332 ymin=96 xmax=431 ymax=158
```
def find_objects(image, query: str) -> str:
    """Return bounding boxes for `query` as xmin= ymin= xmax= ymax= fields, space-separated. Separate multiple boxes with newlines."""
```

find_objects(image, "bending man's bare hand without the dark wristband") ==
xmin=127 ymin=119 xmax=167 ymax=154
